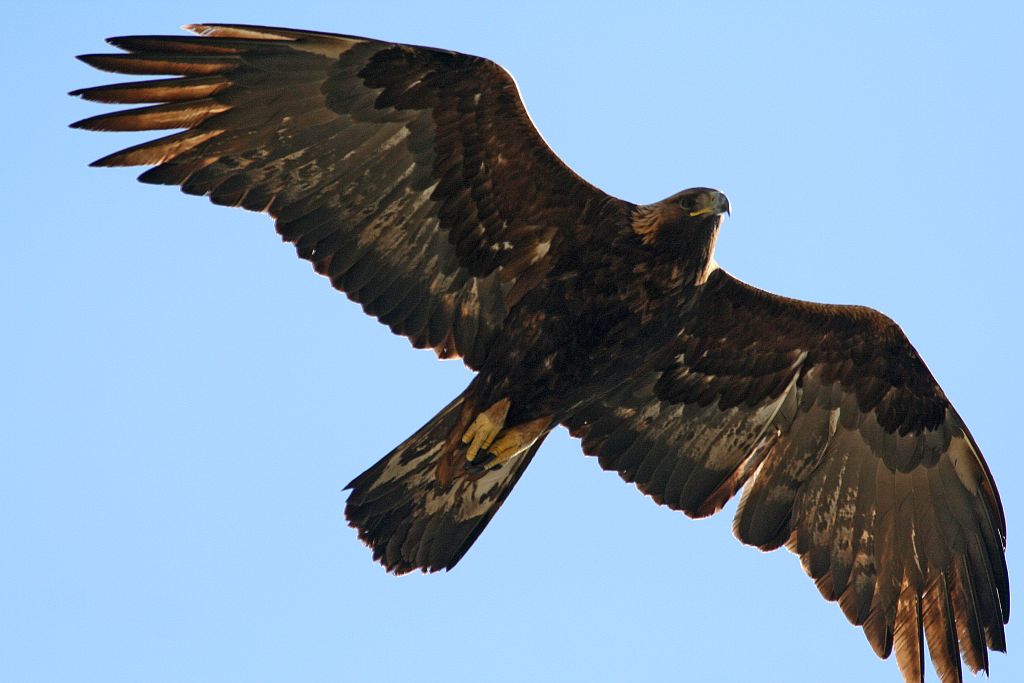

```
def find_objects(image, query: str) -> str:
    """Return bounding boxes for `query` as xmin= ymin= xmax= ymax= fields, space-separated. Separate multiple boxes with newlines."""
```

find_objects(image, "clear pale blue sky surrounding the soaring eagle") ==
xmin=0 ymin=0 xmax=1024 ymax=683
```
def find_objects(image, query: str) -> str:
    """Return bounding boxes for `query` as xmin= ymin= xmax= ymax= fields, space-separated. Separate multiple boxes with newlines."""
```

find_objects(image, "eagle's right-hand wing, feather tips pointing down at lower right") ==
xmin=565 ymin=270 xmax=1010 ymax=681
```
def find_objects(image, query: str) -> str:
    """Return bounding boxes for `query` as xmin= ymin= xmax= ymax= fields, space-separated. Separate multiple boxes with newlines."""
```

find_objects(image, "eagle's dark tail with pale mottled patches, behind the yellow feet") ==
xmin=345 ymin=393 xmax=550 ymax=574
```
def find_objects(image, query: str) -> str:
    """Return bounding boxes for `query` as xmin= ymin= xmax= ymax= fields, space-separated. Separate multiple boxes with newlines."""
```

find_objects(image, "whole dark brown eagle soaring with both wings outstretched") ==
xmin=72 ymin=25 xmax=1010 ymax=682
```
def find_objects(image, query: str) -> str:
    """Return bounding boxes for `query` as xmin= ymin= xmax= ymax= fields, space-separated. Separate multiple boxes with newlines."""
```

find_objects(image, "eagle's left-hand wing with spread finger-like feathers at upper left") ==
xmin=72 ymin=25 xmax=625 ymax=368
